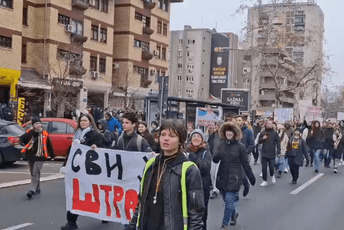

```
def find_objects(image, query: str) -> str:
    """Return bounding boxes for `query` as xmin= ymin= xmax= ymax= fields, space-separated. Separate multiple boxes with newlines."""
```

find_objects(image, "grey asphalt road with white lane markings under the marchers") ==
xmin=0 ymin=158 xmax=344 ymax=230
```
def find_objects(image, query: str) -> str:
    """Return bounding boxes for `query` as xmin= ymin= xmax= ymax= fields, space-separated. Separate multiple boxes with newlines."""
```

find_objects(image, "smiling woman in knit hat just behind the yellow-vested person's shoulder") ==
xmin=187 ymin=129 xmax=211 ymax=230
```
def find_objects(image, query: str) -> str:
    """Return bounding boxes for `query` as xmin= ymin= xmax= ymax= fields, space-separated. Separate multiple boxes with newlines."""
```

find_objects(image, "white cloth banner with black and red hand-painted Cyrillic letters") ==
xmin=65 ymin=143 xmax=152 ymax=224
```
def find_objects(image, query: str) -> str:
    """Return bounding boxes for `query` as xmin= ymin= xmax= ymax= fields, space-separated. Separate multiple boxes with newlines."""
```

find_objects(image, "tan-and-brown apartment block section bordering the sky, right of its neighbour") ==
xmin=113 ymin=0 xmax=183 ymax=105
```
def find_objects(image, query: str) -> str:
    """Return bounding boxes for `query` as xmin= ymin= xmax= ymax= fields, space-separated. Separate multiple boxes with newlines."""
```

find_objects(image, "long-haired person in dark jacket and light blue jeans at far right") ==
xmin=307 ymin=121 xmax=325 ymax=173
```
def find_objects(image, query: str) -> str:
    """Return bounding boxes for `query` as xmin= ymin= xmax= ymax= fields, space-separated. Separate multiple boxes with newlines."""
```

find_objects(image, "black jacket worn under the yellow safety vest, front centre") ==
xmin=124 ymin=153 xmax=205 ymax=230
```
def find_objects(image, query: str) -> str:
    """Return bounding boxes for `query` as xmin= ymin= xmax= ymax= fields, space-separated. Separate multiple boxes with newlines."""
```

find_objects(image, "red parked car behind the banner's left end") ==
xmin=23 ymin=117 xmax=78 ymax=157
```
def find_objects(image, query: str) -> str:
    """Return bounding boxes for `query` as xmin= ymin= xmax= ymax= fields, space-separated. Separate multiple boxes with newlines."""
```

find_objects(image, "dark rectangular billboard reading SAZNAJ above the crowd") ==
xmin=221 ymin=88 xmax=250 ymax=112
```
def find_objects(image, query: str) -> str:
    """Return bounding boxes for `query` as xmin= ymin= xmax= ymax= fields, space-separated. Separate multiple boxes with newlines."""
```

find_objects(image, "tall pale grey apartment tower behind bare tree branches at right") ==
xmin=245 ymin=2 xmax=324 ymax=113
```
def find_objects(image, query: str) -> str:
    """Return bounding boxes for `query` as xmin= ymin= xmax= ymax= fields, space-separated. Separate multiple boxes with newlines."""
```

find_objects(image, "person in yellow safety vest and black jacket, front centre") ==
xmin=124 ymin=120 xmax=204 ymax=230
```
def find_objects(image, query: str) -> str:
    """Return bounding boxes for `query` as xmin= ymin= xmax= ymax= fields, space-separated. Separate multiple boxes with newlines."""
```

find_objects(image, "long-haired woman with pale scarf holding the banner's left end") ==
xmin=61 ymin=113 xmax=103 ymax=230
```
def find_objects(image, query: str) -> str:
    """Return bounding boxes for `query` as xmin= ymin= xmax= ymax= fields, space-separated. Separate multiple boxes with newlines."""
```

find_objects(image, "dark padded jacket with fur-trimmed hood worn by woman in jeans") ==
xmin=213 ymin=122 xmax=256 ymax=192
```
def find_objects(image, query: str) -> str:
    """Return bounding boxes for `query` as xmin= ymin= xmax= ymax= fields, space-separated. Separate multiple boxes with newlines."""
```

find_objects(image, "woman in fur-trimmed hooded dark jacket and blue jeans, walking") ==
xmin=213 ymin=122 xmax=256 ymax=229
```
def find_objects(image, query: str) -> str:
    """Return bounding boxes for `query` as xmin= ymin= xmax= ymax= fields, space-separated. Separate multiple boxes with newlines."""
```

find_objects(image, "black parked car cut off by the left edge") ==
xmin=0 ymin=120 xmax=25 ymax=165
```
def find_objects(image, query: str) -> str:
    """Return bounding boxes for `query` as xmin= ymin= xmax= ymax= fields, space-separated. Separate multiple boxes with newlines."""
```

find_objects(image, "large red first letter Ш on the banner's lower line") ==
xmin=73 ymin=178 xmax=100 ymax=214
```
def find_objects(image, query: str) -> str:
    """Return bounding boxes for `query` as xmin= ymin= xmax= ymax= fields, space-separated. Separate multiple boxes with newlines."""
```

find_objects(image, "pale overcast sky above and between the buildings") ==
xmin=171 ymin=0 xmax=344 ymax=89
